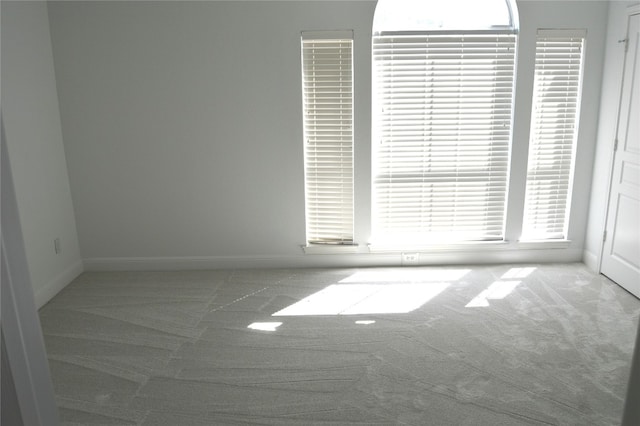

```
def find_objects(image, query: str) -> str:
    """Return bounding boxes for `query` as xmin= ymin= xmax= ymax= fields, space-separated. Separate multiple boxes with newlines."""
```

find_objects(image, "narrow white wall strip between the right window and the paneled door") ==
xmin=584 ymin=1 xmax=638 ymax=271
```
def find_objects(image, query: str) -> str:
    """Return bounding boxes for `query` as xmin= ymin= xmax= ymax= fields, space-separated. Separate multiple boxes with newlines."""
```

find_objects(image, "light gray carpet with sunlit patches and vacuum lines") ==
xmin=40 ymin=264 xmax=640 ymax=426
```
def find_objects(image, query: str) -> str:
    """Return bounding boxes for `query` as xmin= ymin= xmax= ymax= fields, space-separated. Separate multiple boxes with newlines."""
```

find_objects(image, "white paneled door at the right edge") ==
xmin=601 ymin=9 xmax=640 ymax=297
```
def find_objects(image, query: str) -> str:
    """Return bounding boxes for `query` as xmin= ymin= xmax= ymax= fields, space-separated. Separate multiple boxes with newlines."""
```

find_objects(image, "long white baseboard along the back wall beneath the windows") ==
xmin=83 ymin=249 xmax=583 ymax=271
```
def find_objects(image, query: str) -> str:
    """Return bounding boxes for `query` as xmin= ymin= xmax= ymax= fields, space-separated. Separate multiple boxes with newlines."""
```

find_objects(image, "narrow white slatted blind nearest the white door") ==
xmin=522 ymin=30 xmax=586 ymax=240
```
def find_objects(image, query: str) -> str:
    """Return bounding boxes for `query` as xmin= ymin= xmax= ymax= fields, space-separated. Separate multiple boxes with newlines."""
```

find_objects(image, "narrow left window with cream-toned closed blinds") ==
xmin=302 ymin=31 xmax=353 ymax=244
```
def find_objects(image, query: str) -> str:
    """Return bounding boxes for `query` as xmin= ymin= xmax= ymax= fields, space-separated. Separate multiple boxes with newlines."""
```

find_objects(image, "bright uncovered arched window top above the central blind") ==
xmin=373 ymin=0 xmax=518 ymax=33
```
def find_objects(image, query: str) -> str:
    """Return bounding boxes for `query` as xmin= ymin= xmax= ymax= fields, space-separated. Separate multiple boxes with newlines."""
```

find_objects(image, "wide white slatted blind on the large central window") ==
xmin=373 ymin=32 xmax=516 ymax=245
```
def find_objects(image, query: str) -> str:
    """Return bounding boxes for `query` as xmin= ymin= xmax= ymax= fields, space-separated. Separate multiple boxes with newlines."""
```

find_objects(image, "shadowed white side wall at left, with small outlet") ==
xmin=2 ymin=1 xmax=82 ymax=306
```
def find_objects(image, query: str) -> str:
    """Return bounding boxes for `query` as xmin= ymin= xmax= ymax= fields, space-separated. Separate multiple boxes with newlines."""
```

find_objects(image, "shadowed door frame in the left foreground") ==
xmin=0 ymin=111 xmax=59 ymax=426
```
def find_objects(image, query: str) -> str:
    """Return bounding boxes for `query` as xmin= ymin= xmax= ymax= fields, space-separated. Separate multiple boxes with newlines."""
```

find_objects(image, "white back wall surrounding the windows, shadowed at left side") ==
xmin=49 ymin=1 xmax=607 ymax=268
